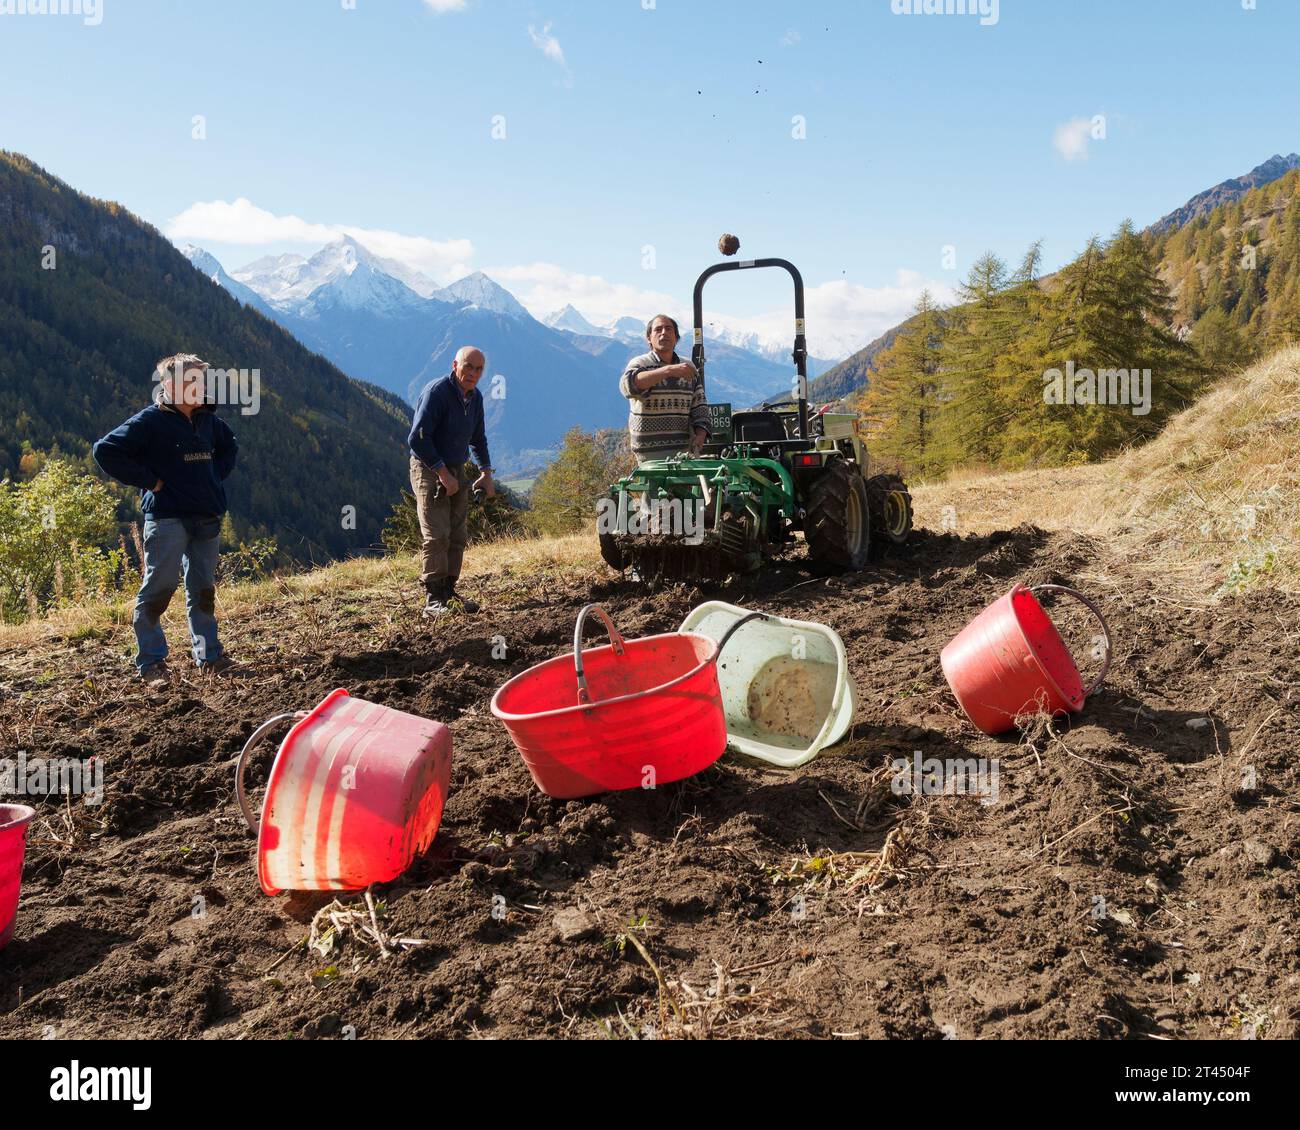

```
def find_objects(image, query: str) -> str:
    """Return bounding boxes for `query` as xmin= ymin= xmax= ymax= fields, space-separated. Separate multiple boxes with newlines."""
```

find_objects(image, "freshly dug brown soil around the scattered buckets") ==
xmin=0 ymin=527 xmax=1300 ymax=1039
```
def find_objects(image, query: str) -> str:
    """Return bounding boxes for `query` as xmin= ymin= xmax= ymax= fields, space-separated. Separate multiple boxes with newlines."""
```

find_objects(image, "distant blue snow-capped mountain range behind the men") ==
xmin=182 ymin=237 xmax=829 ymax=475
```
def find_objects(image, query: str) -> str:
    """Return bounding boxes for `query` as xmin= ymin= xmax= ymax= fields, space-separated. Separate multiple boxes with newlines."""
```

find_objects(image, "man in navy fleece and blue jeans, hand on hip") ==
xmin=94 ymin=354 xmax=239 ymax=688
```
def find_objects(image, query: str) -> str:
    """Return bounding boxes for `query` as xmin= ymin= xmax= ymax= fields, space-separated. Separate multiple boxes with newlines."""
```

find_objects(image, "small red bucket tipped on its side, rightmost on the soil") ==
xmin=940 ymin=585 xmax=1110 ymax=733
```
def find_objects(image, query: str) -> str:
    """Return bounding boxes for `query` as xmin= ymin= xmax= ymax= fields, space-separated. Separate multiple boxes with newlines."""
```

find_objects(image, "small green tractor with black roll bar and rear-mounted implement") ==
xmin=597 ymin=259 xmax=911 ymax=584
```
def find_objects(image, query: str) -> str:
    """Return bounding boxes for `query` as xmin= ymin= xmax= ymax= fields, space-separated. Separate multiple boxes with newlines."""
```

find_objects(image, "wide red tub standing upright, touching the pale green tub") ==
xmin=491 ymin=605 xmax=753 ymax=800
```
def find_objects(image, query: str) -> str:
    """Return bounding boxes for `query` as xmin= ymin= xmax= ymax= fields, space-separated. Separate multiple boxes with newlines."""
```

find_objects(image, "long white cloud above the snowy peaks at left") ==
xmin=166 ymin=196 xmax=475 ymax=285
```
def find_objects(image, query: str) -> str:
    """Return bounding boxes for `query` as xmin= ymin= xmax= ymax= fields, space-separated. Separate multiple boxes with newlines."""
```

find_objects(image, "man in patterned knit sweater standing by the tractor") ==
xmin=619 ymin=313 xmax=709 ymax=463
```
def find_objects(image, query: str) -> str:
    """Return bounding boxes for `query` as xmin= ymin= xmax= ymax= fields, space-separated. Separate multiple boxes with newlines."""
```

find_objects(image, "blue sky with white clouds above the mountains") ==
xmin=0 ymin=0 xmax=1300 ymax=355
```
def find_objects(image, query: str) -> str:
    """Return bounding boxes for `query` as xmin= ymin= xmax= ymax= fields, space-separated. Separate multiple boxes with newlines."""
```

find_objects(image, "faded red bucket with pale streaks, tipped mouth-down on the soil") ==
xmin=235 ymin=690 xmax=451 ymax=895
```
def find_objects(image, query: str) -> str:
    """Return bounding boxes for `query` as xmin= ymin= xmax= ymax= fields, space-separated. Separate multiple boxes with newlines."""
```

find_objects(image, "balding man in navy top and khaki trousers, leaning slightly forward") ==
xmin=407 ymin=346 xmax=497 ymax=618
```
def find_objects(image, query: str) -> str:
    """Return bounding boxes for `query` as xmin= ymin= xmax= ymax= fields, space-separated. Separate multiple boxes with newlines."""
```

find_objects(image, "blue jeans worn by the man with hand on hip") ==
xmin=131 ymin=518 xmax=221 ymax=671
